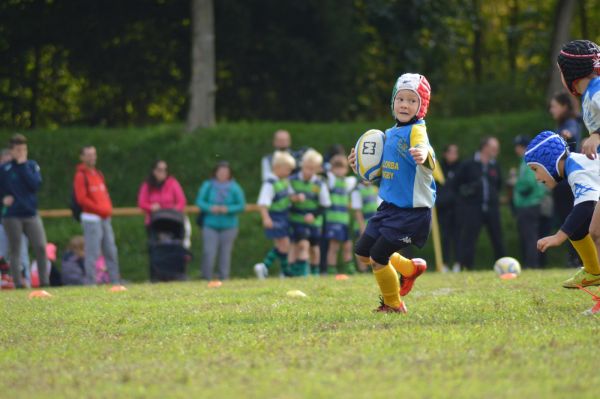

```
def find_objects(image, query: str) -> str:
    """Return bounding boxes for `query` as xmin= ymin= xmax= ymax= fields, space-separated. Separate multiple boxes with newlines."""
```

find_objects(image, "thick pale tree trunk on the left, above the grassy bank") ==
xmin=187 ymin=0 xmax=216 ymax=132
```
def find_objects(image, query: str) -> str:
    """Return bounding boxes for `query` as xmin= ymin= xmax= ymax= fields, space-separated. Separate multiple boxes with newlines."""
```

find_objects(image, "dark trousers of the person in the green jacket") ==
xmin=516 ymin=205 xmax=540 ymax=268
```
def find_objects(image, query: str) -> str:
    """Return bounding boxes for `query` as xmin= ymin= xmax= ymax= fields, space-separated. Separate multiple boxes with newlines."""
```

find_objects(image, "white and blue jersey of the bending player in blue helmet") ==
xmin=565 ymin=153 xmax=600 ymax=205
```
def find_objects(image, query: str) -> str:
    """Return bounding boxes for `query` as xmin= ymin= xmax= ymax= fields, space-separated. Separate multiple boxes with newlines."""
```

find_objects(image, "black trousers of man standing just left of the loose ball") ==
xmin=460 ymin=205 xmax=505 ymax=268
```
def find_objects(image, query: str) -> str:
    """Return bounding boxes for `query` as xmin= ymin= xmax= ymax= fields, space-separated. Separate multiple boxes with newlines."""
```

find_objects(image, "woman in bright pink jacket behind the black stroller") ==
xmin=138 ymin=160 xmax=186 ymax=226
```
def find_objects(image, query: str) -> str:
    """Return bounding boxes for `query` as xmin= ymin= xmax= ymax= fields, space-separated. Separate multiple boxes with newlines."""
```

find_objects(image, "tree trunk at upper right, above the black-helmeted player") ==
xmin=546 ymin=0 xmax=577 ymax=100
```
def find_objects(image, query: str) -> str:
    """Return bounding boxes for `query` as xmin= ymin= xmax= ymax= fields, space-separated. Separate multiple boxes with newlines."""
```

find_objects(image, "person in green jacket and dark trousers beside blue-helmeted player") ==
xmin=513 ymin=136 xmax=546 ymax=268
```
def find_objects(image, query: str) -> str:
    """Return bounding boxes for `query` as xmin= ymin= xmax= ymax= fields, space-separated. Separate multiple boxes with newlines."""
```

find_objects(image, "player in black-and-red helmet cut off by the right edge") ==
xmin=557 ymin=40 xmax=600 ymax=268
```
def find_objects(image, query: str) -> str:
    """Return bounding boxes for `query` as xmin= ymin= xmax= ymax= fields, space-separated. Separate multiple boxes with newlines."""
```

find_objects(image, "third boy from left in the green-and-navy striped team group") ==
xmin=325 ymin=155 xmax=356 ymax=275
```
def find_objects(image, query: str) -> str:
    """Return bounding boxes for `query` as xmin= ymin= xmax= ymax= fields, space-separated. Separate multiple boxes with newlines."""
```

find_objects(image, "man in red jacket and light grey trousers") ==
xmin=73 ymin=146 xmax=121 ymax=285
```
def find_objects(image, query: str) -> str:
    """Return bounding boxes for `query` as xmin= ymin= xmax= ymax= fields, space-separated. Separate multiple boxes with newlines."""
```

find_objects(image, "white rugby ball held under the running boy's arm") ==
xmin=354 ymin=129 xmax=385 ymax=182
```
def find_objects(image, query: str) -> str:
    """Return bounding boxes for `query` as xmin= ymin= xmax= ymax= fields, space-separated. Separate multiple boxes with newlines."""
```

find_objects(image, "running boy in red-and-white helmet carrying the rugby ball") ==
xmin=348 ymin=73 xmax=435 ymax=313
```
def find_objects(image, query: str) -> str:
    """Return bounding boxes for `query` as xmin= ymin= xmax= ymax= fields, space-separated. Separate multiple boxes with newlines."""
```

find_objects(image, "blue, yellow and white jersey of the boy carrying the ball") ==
xmin=379 ymin=119 xmax=435 ymax=208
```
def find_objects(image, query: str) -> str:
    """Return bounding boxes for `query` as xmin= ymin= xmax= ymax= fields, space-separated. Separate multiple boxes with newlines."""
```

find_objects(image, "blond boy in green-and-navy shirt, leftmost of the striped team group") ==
xmin=254 ymin=151 xmax=296 ymax=279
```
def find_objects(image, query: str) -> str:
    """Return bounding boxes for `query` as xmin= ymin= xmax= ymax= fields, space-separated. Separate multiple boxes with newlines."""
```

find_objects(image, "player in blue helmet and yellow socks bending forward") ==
xmin=525 ymin=131 xmax=600 ymax=288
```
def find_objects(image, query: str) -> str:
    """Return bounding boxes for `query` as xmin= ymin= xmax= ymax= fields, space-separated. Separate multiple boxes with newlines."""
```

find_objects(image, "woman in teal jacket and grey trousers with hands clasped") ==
xmin=196 ymin=162 xmax=246 ymax=280
